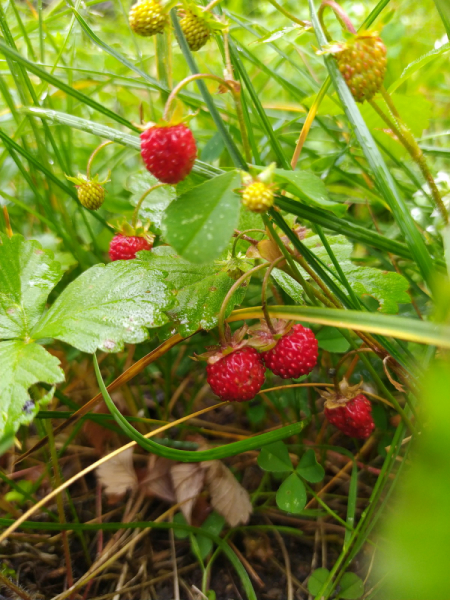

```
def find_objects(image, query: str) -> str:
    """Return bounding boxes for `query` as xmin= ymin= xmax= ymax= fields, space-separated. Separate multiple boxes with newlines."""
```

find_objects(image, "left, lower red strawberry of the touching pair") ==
xmin=206 ymin=346 xmax=266 ymax=402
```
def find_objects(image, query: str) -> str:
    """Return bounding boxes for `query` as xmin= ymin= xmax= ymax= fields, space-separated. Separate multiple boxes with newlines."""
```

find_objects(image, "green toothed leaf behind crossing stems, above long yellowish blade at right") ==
xmin=284 ymin=235 xmax=411 ymax=313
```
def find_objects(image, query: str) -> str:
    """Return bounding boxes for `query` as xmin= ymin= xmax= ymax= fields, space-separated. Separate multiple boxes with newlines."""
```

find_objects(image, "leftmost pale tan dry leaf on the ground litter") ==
xmin=96 ymin=448 xmax=138 ymax=496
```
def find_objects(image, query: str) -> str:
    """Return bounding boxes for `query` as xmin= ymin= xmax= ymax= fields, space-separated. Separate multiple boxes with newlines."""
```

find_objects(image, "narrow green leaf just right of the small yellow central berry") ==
xmin=275 ymin=169 xmax=348 ymax=216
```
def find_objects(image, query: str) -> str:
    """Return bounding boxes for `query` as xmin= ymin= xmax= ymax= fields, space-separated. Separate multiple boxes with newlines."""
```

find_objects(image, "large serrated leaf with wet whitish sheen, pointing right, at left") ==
xmin=32 ymin=260 xmax=174 ymax=353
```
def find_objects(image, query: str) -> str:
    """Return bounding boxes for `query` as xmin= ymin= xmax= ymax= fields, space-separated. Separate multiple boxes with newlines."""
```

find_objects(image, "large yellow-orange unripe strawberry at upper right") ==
xmin=333 ymin=32 xmax=387 ymax=102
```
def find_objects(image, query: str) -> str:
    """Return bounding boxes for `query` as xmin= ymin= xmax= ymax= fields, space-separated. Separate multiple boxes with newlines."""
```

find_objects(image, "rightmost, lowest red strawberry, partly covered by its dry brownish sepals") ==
xmin=324 ymin=394 xmax=375 ymax=439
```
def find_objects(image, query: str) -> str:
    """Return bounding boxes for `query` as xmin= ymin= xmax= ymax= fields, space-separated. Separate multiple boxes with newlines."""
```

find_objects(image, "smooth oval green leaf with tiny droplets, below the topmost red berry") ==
xmin=162 ymin=171 xmax=241 ymax=264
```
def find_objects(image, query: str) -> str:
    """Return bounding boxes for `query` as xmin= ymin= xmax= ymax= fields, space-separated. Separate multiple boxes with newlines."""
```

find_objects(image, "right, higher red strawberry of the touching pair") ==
xmin=262 ymin=325 xmax=318 ymax=379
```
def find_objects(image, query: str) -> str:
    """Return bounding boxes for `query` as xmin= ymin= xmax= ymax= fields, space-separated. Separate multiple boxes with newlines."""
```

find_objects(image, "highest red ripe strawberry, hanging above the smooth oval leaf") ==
xmin=141 ymin=123 xmax=197 ymax=184
